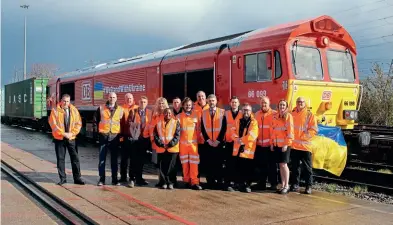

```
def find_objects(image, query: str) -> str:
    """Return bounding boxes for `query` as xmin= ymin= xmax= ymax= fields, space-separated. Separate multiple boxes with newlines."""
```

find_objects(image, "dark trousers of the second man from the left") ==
xmin=98 ymin=134 xmax=120 ymax=183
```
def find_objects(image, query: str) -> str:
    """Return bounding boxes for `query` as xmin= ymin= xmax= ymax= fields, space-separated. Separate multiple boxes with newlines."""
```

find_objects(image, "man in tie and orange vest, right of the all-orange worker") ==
xmin=201 ymin=94 xmax=227 ymax=189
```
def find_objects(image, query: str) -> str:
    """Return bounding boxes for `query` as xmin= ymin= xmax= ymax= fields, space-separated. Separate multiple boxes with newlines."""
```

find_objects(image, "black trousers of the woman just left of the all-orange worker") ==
xmin=157 ymin=151 xmax=179 ymax=185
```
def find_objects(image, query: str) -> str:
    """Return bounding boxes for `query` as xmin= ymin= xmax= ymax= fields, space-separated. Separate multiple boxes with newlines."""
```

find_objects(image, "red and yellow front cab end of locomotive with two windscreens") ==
xmin=286 ymin=16 xmax=362 ymax=129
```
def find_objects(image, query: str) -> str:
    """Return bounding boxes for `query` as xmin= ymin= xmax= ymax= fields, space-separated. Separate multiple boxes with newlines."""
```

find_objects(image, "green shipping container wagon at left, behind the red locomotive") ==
xmin=1 ymin=78 xmax=49 ymax=130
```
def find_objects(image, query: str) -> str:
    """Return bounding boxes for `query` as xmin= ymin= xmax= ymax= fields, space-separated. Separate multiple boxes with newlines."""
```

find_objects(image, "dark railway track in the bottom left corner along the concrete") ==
xmin=1 ymin=160 xmax=98 ymax=225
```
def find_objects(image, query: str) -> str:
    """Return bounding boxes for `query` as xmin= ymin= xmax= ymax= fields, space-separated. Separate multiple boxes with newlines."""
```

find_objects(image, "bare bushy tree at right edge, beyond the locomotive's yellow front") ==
xmin=359 ymin=63 xmax=393 ymax=126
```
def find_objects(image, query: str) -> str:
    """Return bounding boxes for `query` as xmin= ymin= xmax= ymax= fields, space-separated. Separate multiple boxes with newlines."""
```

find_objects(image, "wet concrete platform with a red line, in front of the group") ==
xmin=1 ymin=139 xmax=393 ymax=225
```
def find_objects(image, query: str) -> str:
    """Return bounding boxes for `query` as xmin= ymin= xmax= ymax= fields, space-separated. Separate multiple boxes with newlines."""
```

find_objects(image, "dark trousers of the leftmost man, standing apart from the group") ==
xmin=54 ymin=139 xmax=81 ymax=181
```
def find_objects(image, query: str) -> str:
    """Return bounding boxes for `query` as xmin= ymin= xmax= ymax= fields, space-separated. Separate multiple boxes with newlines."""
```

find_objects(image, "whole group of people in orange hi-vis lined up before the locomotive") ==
xmin=49 ymin=91 xmax=318 ymax=194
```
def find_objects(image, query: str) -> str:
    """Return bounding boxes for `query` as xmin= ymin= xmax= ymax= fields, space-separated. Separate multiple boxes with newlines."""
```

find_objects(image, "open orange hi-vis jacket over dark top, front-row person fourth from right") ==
xmin=232 ymin=117 xmax=258 ymax=159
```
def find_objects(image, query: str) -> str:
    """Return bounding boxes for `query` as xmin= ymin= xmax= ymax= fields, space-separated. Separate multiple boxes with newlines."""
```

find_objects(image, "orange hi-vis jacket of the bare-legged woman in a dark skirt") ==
xmin=270 ymin=112 xmax=294 ymax=147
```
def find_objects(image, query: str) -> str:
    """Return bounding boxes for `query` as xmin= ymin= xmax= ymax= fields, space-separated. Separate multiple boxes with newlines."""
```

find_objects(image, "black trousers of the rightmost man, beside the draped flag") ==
xmin=291 ymin=149 xmax=312 ymax=186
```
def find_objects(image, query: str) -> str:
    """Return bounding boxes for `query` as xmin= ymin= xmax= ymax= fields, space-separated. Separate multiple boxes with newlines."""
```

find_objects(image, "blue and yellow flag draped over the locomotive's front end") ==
xmin=308 ymin=124 xmax=347 ymax=176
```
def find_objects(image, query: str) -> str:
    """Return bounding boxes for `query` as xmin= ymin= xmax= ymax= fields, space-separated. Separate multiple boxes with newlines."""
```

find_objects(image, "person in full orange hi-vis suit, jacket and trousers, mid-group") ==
xmin=177 ymin=97 xmax=202 ymax=190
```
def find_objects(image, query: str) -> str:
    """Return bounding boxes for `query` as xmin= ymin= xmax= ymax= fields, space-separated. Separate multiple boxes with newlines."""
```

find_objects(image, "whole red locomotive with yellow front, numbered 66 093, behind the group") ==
xmin=48 ymin=16 xmax=368 ymax=146
